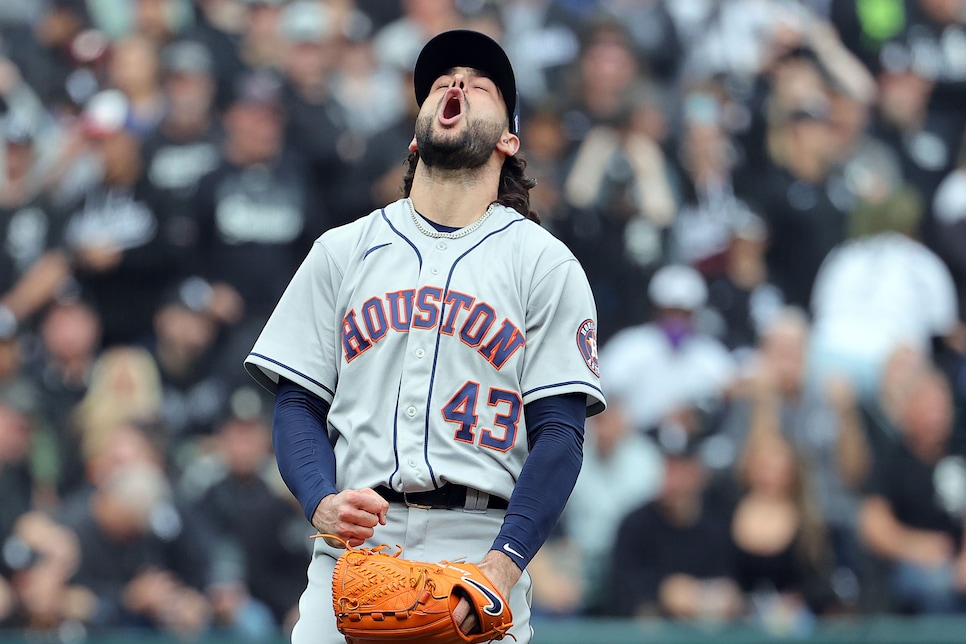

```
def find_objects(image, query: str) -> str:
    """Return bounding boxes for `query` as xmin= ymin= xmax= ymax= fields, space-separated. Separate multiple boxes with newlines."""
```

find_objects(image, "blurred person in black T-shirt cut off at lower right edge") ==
xmin=859 ymin=369 xmax=966 ymax=613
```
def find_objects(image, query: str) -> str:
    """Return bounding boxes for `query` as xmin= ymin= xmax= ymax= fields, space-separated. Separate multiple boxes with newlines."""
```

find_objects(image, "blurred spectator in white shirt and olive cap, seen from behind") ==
xmin=810 ymin=176 xmax=958 ymax=397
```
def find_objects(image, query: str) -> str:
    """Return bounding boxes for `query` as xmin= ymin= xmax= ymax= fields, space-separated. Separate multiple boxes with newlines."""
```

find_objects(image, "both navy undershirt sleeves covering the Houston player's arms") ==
xmin=272 ymin=378 xmax=586 ymax=569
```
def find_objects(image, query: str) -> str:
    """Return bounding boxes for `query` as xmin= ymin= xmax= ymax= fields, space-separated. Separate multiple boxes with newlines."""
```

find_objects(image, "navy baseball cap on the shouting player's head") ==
xmin=413 ymin=29 xmax=520 ymax=134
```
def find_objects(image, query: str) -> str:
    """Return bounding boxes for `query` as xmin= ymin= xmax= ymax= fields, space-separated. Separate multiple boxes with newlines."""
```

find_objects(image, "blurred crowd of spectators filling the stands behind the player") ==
xmin=0 ymin=0 xmax=966 ymax=641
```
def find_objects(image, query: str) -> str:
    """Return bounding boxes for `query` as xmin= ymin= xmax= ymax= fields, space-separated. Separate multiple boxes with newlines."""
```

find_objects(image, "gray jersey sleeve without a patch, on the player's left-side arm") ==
xmin=245 ymin=241 xmax=342 ymax=403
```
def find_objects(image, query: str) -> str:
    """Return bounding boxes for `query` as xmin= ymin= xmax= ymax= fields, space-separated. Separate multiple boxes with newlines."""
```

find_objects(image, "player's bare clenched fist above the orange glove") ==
xmin=312 ymin=488 xmax=389 ymax=548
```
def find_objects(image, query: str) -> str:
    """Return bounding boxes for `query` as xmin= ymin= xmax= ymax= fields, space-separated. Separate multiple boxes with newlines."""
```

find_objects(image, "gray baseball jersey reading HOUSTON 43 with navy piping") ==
xmin=245 ymin=199 xmax=604 ymax=499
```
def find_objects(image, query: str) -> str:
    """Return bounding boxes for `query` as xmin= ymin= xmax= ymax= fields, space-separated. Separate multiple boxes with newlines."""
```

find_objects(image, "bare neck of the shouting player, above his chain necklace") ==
xmin=409 ymin=166 xmax=499 ymax=228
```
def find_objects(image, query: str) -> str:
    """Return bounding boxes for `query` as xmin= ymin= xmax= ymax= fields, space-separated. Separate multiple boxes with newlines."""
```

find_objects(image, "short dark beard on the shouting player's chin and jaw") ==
xmin=416 ymin=114 xmax=504 ymax=170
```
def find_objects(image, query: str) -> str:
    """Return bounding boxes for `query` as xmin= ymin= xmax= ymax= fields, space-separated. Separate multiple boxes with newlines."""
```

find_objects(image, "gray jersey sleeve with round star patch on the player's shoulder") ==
xmin=523 ymin=259 xmax=605 ymax=416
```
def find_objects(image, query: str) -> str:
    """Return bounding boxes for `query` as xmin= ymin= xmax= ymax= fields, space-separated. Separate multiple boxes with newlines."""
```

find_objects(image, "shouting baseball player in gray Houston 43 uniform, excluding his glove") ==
xmin=245 ymin=30 xmax=605 ymax=644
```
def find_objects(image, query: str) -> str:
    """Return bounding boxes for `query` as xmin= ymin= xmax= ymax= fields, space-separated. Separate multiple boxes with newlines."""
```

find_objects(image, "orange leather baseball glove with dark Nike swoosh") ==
xmin=320 ymin=535 xmax=516 ymax=644
